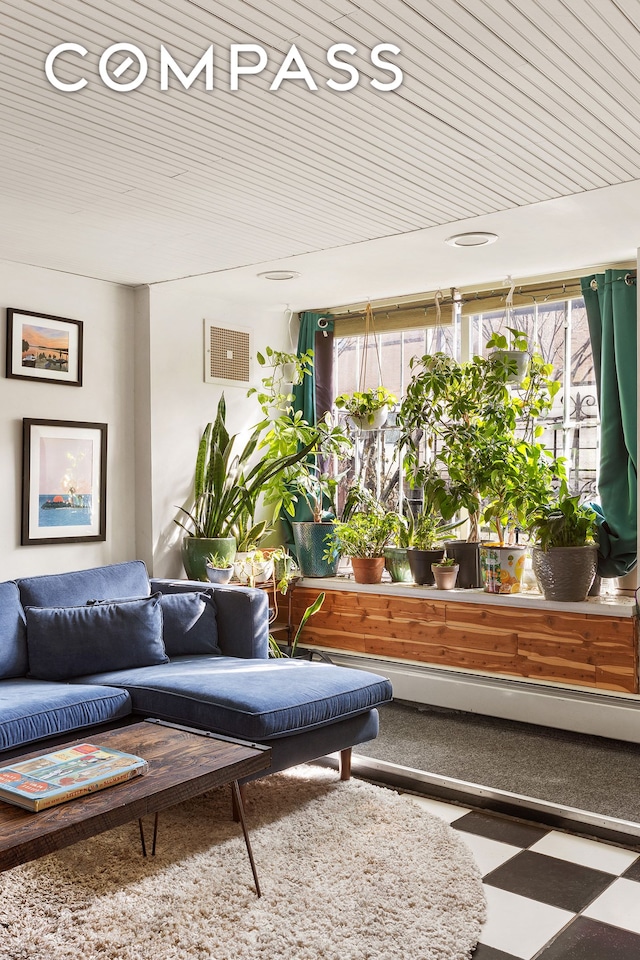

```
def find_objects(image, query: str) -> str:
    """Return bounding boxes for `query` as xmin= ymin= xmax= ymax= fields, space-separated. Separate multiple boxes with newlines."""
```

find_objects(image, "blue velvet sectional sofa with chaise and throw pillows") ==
xmin=0 ymin=561 xmax=392 ymax=772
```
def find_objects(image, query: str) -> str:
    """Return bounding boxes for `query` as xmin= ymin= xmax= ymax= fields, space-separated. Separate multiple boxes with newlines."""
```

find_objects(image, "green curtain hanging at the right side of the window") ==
xmin=581 ymin=270 xmax=638 ymax=577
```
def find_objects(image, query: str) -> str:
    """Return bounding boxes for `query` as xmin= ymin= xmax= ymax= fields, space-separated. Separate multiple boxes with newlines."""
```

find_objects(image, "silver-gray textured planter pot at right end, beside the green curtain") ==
xmin=532 ymin=544 xmax=598 ymax=603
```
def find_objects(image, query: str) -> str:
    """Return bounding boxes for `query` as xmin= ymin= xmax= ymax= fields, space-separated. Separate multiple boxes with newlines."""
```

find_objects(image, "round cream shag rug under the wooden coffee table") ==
xmin=0 ymin=766 xmax=485 ymax=960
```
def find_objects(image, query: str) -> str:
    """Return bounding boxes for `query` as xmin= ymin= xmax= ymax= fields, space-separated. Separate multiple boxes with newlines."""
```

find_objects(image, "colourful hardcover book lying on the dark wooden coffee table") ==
xmin=0 ymin=743 xmax=148 ymax=812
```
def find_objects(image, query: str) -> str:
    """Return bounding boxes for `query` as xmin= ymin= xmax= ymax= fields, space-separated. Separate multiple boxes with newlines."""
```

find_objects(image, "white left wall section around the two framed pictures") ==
xmin=0 ymin=261 xmax=135 ymax=580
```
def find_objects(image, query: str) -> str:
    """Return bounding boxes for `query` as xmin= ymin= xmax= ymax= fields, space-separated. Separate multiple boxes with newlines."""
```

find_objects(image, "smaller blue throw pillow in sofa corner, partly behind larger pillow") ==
xmin=160 ymin=591 xmax=221 ymax=657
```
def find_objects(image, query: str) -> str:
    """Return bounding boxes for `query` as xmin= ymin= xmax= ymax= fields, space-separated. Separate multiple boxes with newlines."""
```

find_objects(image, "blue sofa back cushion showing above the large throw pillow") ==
xmin=18 ymin=560 xmax=149 ymax=607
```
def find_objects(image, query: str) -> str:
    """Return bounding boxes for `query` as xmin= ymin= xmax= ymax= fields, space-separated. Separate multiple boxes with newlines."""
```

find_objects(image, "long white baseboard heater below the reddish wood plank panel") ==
xmin=326 ymin=650 xmax=640 ymax=743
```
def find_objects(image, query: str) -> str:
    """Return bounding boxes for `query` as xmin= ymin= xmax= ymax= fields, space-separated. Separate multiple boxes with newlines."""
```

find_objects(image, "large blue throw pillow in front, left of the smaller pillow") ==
xmin=25 ymin=593 xmax=169 ymax=680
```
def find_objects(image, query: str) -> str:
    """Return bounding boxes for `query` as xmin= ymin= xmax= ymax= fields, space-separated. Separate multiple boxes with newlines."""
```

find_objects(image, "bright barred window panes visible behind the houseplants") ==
xmin=334 ymin=297 xmax=600 ymax=509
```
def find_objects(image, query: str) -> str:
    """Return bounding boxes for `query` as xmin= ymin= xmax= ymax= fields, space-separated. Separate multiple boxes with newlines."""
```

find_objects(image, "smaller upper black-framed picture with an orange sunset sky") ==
xmin=7 ymin=307 xmax=82 ymax=387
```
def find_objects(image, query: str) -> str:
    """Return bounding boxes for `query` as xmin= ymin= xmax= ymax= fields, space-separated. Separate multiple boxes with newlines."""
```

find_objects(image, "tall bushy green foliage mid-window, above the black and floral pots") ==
xmin=398 ymin=340 xmax=563 ymax=543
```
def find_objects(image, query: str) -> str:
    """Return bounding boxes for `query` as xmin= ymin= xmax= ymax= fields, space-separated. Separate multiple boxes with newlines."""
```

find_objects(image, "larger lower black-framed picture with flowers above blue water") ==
xmin=21 ymin=419 xmax=107 ymax=545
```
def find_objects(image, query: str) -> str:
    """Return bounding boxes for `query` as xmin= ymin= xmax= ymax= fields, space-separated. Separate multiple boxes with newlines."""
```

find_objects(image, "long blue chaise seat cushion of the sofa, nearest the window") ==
xmin=69 ymin=657 xmax=392 ymax=741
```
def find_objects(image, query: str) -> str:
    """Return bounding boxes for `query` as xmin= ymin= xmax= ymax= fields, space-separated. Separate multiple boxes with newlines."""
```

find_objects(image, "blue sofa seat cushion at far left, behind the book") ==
xmin=0 ymin=677 xmax=131 ymax=751
